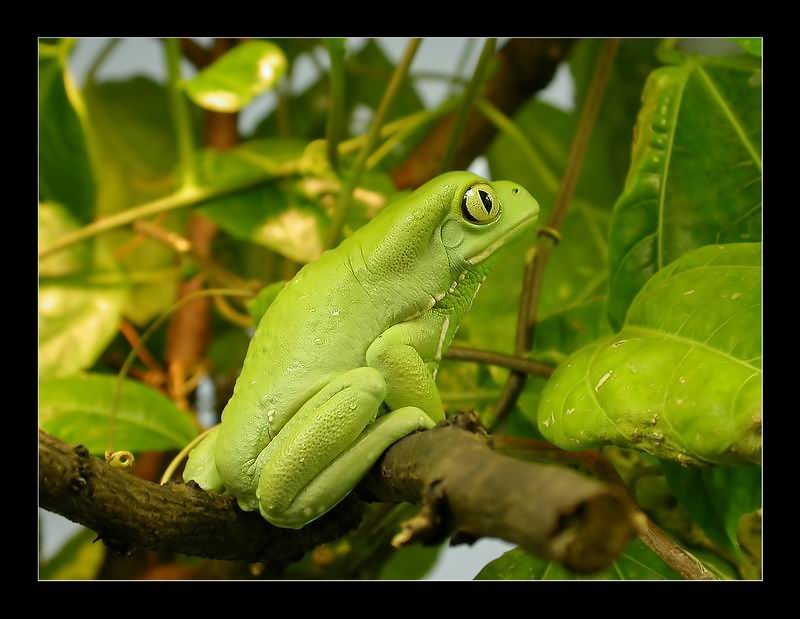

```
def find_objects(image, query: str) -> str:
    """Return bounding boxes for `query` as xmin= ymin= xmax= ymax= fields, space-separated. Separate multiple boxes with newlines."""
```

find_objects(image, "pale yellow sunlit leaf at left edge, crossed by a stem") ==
xmin=38 ymin=204 xmax=128 ymax=377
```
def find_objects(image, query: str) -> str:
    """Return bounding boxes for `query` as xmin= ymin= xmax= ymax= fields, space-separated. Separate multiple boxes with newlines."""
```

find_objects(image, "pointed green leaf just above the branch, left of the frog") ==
xmin=39 ymin=374 xmax=197 ymax=454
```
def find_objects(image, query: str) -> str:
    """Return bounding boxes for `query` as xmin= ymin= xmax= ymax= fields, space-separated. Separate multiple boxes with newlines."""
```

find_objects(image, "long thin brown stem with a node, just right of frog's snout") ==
xmin=493 ymin=39 xmax=619 ymax=425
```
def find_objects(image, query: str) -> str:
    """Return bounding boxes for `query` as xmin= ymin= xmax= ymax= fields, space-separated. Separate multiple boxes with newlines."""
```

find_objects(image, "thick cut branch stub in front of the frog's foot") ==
xmin=365 ymin=416 xmax=644 ymax=572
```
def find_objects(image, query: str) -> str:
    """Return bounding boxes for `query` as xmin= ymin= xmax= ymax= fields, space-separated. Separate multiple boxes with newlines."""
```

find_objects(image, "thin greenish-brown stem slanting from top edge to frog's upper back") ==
xmin=327 ymin=38 xmax=420 ymax=247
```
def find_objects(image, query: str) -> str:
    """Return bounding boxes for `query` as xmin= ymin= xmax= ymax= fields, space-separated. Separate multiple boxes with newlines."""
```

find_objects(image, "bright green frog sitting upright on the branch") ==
xmin=183 ymin=171 xmax=539 ymax=529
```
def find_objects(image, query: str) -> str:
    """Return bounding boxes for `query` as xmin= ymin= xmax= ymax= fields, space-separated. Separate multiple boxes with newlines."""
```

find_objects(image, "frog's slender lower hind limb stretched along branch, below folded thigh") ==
xmin=273 ymin=406 xmax=436 ymax=528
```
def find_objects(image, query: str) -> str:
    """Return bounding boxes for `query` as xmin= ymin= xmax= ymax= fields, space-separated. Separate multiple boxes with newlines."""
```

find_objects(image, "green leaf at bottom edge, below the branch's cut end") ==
xmin=475 ymin=539 xmax=681 ymax=580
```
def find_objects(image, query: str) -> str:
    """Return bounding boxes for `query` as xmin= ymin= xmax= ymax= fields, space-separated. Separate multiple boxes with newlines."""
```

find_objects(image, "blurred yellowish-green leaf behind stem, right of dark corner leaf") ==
xmin=85 ymin=76 xmax=187 ymax=324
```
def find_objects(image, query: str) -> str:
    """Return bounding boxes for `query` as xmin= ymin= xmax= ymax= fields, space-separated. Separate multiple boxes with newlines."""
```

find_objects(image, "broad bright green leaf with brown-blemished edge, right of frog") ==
xmin=538 ymin=243 xmax=762 ymax=464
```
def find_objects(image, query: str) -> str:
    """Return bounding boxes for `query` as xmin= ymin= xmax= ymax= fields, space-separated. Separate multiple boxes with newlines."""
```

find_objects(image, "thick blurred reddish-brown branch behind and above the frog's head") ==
xmin=392 ymin=39 xmax=572 ymax=189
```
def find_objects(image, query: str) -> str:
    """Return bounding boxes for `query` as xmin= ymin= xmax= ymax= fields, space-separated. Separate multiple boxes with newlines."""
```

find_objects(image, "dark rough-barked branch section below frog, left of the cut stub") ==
xmin=39 ymin=430 xmax=361 ymax=565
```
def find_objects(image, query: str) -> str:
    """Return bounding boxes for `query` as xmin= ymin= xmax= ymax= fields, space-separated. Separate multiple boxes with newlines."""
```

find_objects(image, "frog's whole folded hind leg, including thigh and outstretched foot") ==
xmin=256 ymin=367 xmax=434 ymax=529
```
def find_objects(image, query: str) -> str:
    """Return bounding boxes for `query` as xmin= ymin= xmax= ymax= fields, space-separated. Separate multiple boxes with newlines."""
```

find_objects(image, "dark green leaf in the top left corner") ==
xmin=39 ymin=43 xmax=95 ymax=223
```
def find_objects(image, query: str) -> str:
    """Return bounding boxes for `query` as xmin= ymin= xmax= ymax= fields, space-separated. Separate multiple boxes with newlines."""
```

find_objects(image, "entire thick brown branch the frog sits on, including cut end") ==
xmin=39 ymin=416 xmax=642 ymax=572
